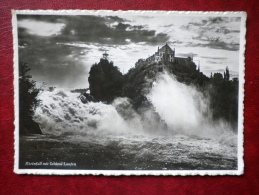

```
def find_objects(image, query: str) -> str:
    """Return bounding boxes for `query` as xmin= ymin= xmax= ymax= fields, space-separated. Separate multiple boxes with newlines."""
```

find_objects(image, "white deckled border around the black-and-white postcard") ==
xmin=11 ymin=10 xmax=247 ymax=176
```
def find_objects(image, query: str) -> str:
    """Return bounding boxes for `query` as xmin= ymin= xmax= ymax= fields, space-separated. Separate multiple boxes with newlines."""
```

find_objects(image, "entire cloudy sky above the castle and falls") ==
xmin=17 ymin=12 xmax=241 ymax=88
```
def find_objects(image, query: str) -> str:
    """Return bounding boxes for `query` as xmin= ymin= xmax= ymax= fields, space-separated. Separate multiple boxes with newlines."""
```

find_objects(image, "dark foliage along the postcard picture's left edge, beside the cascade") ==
xmin=19 ymin=63 xmax=42 ymax=135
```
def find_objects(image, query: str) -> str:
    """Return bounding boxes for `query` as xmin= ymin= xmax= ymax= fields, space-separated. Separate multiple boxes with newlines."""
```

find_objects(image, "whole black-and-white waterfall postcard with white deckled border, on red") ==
xmin=13 ymin=10 xmax=246 ymax=175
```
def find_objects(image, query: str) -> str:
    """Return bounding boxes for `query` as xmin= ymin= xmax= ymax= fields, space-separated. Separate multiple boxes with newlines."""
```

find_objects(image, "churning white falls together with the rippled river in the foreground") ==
xmin=26 ymin=73 xmax=240 ymax=170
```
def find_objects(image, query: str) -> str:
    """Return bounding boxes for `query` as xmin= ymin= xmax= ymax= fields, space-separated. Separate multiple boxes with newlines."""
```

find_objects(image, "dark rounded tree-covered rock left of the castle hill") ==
xmin=88 ymin=59 xmax=123 ymax=103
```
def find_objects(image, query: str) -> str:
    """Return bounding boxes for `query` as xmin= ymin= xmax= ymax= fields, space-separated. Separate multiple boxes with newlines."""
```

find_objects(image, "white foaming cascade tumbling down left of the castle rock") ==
xmin=34 ymin=89 xmax=145 ymax=135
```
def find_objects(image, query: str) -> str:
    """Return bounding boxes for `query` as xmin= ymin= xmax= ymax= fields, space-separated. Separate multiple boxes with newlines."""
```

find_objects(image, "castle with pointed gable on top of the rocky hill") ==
xmin=145 ymin=43 xmax=199 ymax=70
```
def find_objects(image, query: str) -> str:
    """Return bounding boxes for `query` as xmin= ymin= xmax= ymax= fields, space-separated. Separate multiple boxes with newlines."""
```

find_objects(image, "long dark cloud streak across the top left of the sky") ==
xmin=18 ymin=15 xmax=169 ymax=44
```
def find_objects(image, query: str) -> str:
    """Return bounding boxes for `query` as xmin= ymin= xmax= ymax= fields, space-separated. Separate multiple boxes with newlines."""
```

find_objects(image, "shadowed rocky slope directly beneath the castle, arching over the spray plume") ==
xmin=123 ymin=60 xmax=205 ymax=108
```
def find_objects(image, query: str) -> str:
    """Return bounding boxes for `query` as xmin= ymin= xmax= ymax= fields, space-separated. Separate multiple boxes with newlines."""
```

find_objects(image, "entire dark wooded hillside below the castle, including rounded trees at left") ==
xmin=89 ymin=48 xmax=238 ymax=130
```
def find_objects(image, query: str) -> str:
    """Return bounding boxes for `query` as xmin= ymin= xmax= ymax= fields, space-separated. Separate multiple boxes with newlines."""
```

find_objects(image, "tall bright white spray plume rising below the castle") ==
xmin=148 ymin=72 xmax=236 ymax=137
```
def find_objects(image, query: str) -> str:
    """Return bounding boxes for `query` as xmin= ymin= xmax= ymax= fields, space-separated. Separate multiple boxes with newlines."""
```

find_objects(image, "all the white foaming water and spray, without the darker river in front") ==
xmin=34 ymin=73 xmax=237 ymax=145
